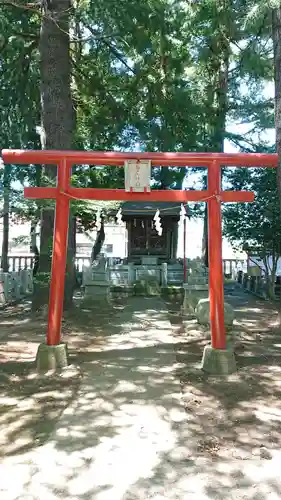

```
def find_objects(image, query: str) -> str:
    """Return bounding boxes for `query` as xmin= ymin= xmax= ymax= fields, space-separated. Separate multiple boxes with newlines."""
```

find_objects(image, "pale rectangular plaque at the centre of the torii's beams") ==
xmin=124 ymin=160 xmax=151 ymax=193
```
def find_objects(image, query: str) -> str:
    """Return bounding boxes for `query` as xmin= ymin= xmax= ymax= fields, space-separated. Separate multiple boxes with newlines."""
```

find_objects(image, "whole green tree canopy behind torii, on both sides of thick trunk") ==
xmin=0 ymin=0 xmax=273 ymax=236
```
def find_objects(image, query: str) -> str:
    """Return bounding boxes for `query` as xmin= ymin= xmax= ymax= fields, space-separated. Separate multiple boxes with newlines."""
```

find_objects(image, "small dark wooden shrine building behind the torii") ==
xmin=121 ymin=201 xmax=187 ymax=264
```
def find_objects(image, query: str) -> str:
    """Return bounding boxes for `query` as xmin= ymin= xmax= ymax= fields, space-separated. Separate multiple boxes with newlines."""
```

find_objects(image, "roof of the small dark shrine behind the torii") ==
xmin=121 ymin=201 xmax=189 ymax=217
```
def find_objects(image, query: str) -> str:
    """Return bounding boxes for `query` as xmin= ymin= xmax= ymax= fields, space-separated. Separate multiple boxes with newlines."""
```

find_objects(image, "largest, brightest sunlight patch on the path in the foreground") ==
xmin=10 ymin=404 xmax=184 ymax=500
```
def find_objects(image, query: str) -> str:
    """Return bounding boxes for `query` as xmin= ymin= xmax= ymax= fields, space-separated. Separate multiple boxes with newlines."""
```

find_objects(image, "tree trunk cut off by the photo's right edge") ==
xmin=272 ymin=7 xmax=281 ymax=322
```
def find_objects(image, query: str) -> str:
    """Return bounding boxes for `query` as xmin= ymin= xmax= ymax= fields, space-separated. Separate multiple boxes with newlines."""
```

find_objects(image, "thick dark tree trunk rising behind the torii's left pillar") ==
xmin=33 ymin=0 xmax=75 ymax=309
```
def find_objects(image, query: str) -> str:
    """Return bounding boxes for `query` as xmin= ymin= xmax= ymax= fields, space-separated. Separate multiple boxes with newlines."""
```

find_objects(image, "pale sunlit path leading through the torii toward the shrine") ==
xmin=0 ymin=299 xmax=190 ymax=500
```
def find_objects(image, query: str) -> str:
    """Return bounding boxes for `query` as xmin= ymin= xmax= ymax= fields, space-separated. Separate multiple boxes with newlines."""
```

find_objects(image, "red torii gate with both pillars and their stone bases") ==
xmin=2 ymin=150 xmax=277 ymax=375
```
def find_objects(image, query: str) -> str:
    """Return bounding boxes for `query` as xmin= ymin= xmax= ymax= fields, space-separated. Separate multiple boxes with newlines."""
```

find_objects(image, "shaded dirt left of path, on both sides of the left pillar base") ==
xmin=0 ymin=296 xmax=167 ymax=457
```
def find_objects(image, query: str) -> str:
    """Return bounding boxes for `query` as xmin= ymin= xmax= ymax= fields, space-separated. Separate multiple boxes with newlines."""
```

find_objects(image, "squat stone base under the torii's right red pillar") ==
xmin=201 ymin=345 xmax=237 ymax=375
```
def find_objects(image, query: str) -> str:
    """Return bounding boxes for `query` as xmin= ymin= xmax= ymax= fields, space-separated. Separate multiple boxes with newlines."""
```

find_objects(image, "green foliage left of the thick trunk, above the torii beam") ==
xmin=0 ymin=2 xmax=40 ymax=148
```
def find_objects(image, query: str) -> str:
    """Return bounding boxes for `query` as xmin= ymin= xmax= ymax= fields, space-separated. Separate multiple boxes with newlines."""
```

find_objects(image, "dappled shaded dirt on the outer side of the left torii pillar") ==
xmin=0 ymin=304 xmax=80 ymax=458
